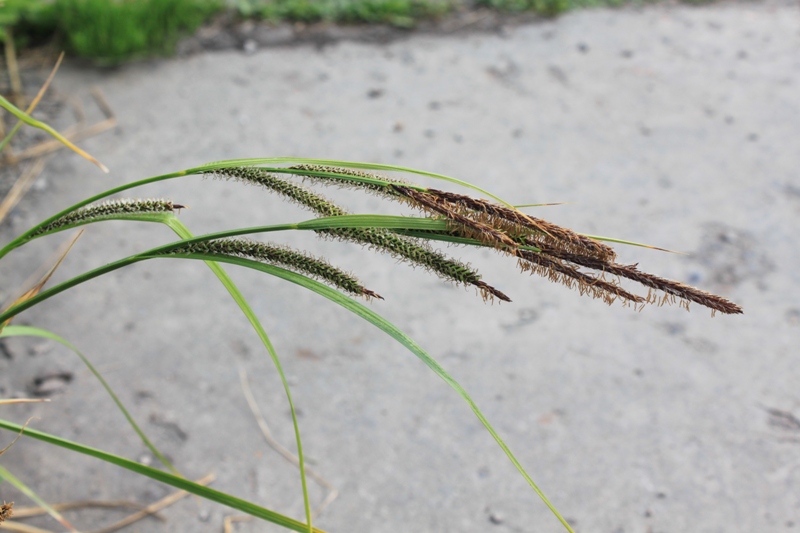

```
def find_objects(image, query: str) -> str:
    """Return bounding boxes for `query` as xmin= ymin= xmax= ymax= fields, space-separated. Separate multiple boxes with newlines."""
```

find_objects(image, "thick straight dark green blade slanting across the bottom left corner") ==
xmin=0 ymin=419 xmax=325 ymax=533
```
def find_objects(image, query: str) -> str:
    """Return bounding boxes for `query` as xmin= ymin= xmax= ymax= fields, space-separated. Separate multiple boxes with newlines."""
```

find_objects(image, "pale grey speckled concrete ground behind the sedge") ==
xmin=0 ymin=2 xmax=800 ymax=533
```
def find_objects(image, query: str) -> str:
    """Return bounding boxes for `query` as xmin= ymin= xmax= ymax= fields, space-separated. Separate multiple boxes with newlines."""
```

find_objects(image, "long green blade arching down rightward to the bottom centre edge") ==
xmin=138 ymin=254 xmax=574 ymax=533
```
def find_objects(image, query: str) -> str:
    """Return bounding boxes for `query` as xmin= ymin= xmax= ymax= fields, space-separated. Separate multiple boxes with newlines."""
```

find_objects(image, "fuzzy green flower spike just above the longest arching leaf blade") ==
xmin=166 ymin=239 xmax=383 ymax=300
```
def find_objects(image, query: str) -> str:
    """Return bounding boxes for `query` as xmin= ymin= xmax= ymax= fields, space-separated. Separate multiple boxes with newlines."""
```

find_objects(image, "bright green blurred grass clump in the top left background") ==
xmin=54 ymin=0 xmax=224 ymax=64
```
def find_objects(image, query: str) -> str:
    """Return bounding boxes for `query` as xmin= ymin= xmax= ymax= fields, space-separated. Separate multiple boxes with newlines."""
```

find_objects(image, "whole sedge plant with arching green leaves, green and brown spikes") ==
xmin=0 ymin=97 xmax=742 ymax=532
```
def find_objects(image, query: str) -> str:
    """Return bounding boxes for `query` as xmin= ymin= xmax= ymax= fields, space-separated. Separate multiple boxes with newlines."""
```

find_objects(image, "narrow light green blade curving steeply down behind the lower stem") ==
xmin=165 ymin=216 xmax=313 ymax=533
